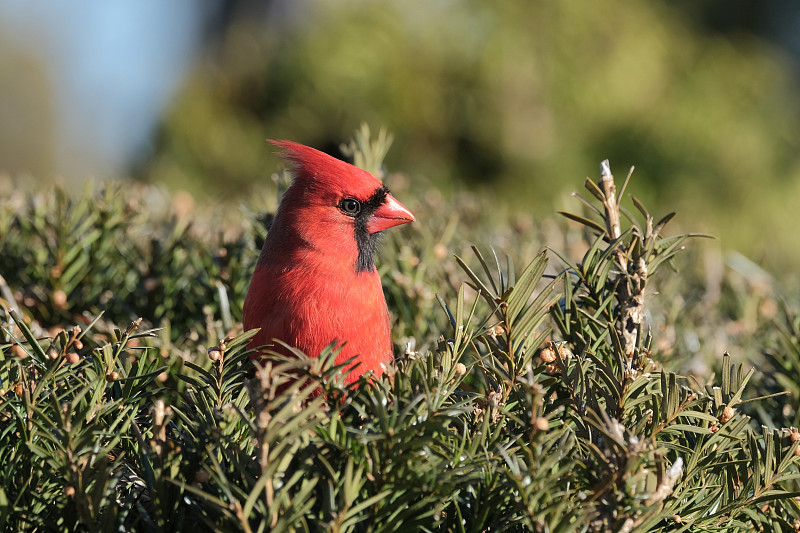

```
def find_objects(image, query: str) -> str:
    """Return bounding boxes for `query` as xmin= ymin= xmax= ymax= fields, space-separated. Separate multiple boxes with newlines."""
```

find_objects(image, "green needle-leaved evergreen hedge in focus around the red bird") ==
xmin=0 ymin=129 xmax=800 ymax=533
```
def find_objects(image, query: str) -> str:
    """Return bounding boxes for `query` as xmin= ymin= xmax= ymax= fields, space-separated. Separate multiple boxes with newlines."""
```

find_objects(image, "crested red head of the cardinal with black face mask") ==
xmin=270 ymin=141 xmax=414 ymax=272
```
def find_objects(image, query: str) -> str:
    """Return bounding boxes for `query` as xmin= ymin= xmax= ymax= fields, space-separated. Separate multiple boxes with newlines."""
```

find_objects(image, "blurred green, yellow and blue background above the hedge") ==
xmin=0 ymin=0 xmax=800 ymax=278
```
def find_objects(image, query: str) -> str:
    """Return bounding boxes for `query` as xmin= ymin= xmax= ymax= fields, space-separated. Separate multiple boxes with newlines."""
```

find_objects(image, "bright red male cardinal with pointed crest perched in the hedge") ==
xmin=242 ymin=141 xmax=414 ymax=383
